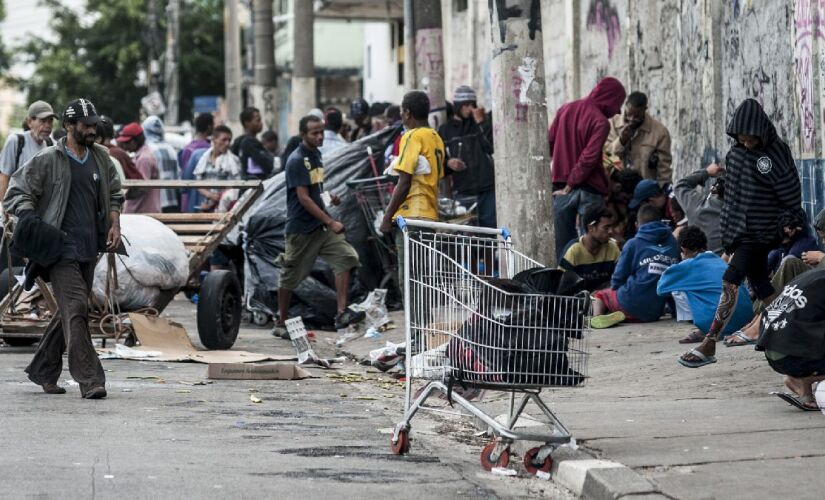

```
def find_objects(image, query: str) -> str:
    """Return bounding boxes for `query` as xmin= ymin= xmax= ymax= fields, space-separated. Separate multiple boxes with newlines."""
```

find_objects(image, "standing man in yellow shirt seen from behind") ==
xmin=381 ymin=90 xmax=444 ymax=289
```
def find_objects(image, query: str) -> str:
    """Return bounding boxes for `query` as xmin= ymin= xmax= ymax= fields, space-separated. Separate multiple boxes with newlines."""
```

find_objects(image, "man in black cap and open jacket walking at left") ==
xmin=3 ymin=99 xmax=123 ymax=399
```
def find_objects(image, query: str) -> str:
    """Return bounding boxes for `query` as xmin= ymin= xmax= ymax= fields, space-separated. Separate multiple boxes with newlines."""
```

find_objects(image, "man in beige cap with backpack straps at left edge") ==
xmin=0 ymin=101 xmax=57 ymax=199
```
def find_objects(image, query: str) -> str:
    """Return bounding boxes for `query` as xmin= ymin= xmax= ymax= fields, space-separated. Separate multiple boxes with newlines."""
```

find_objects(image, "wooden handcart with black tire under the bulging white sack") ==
xmin=0 ymin=180 xmax=263 ymax=349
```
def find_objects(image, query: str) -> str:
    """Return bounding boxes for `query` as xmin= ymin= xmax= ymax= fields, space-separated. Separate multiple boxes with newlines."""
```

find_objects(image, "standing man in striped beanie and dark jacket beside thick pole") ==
xmin=438 ymin=85 xmax=496 ymax=227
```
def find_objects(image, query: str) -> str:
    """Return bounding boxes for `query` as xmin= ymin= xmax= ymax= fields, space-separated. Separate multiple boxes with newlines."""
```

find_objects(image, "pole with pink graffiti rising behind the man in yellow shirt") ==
xmin=405 ymin=0 xmax=447 ymax=129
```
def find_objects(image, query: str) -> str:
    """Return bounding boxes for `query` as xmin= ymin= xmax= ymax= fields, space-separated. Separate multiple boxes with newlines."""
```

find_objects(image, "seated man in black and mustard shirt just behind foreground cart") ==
xmin=559 ymin=206 xmax=620 ymax=292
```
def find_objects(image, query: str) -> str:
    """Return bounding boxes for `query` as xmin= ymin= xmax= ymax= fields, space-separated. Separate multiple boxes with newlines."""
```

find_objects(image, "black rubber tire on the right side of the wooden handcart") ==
xmin=198 ymin=270 xmax=243 ymax=350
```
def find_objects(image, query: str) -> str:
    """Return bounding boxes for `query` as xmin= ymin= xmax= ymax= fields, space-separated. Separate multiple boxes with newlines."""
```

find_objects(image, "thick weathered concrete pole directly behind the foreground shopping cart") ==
xmin=489 ymin=0 xmax=555 ymax=265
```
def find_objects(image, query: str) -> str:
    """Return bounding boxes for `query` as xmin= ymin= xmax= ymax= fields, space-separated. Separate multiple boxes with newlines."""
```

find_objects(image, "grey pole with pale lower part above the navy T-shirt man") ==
xmin=285 ymin=0 xmax=315 ymax=136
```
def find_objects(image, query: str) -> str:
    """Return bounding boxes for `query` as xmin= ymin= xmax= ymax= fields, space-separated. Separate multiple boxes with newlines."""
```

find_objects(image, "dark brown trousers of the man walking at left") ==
xmin=26 ymin=261 xmax=106 ymax=394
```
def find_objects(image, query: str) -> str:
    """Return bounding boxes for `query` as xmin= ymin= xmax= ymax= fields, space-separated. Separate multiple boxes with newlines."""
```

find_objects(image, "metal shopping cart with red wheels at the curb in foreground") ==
xmin=391 ymin=217 xmax=590 ymax=474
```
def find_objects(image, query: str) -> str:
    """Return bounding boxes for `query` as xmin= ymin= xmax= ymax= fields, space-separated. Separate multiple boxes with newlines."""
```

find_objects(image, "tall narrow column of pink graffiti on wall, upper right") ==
xmin=794 ymin=0 xmax=820 ymax=154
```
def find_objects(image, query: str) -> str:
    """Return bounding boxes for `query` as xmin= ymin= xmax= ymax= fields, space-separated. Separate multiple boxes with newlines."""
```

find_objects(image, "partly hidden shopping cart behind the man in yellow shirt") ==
xmin=347 ymin=175 xmax=400 ymax=291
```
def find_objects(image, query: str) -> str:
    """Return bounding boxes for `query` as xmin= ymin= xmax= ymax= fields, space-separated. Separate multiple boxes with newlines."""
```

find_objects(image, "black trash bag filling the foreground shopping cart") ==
xmin=447 ymin=268 xmax=589 ymax=386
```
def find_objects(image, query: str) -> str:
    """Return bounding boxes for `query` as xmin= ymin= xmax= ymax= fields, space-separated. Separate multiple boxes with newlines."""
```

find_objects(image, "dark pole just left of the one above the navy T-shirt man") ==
xmin=250 ymin=0 xmax=278 ymax=134
